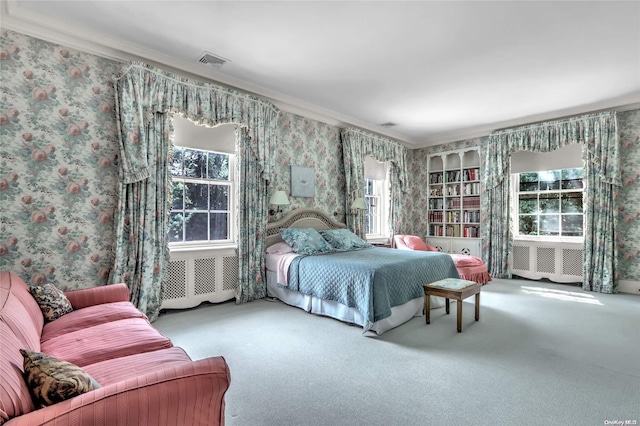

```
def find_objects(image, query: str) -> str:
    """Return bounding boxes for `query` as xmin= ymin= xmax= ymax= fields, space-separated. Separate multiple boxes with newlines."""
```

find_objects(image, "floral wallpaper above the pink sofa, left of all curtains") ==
xmin=0 ymin=31 xmax=118 ymax=289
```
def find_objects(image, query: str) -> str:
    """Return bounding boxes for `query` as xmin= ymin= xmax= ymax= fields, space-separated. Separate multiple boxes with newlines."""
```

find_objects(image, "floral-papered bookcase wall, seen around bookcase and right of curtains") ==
xmin=408 ymin=109 xmax=640 ymax=288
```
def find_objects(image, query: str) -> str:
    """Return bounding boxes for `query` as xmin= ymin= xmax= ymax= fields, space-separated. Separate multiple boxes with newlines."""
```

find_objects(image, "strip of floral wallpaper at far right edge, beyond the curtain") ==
xmin=618 ymin=109 xmax=640 ymax=281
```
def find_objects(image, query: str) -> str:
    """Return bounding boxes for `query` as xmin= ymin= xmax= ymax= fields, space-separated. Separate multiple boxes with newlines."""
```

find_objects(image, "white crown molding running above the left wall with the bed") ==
xmin=0 ymin=0 xmax=416 ymax=148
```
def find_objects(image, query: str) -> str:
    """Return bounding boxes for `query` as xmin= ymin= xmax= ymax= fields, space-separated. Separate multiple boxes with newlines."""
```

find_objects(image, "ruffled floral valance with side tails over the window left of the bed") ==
xmin=115 ymin=62 xmax=278 ymax=183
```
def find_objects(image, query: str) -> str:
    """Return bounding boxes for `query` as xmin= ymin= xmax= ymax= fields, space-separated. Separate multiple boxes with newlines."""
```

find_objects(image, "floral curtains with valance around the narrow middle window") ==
xmin=341 ymin=128 xmax=408 ymax=238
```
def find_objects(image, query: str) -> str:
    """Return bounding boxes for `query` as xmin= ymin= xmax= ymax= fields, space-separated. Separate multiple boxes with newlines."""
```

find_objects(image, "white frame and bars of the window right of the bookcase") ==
xmin=510 ymin=167 xmax=586 ymax=243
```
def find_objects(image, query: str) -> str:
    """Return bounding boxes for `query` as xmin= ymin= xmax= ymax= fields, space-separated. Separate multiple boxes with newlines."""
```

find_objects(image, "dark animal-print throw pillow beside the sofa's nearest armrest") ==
xmin=20 ymin=349 xmax=100 ymax=406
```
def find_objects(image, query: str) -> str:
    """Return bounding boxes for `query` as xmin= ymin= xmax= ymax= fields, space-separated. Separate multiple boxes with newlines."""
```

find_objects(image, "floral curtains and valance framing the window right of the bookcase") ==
xmin=482 ymin=112 xmax=621 ymax=293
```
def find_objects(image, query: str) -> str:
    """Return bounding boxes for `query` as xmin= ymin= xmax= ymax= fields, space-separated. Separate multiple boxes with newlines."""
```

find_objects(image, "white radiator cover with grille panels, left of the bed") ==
xmin=160 ymin=248 xmax=238 ymax=309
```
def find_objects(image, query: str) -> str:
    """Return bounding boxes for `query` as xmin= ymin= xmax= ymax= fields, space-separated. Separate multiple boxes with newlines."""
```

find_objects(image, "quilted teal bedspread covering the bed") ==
xmin=287 ymin=247 xmax=459 ymax=330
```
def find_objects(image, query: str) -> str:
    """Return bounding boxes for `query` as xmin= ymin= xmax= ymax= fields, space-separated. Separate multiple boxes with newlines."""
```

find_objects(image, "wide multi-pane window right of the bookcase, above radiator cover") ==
xmin=513 ymin=168 xmax=584 ymax=238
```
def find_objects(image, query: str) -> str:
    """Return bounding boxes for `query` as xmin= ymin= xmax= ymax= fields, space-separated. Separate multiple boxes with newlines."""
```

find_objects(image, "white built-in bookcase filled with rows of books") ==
xmin=427 ymin=148 xmax=480 ymax=256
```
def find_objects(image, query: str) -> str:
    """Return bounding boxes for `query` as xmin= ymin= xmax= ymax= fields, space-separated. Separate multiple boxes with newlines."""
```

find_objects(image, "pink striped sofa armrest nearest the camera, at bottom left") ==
xmin=5 ymin=357 xmax=231 ymax=426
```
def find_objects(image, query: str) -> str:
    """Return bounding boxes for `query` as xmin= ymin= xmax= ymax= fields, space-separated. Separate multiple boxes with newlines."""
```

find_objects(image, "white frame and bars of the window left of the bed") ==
xmin=167 ymin=146 xmax=238 ymax=251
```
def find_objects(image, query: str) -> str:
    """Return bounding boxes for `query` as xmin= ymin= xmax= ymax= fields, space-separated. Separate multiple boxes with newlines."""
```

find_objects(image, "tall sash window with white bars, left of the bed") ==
xmin=169 ymin=147 xmax=234 ymax=243
